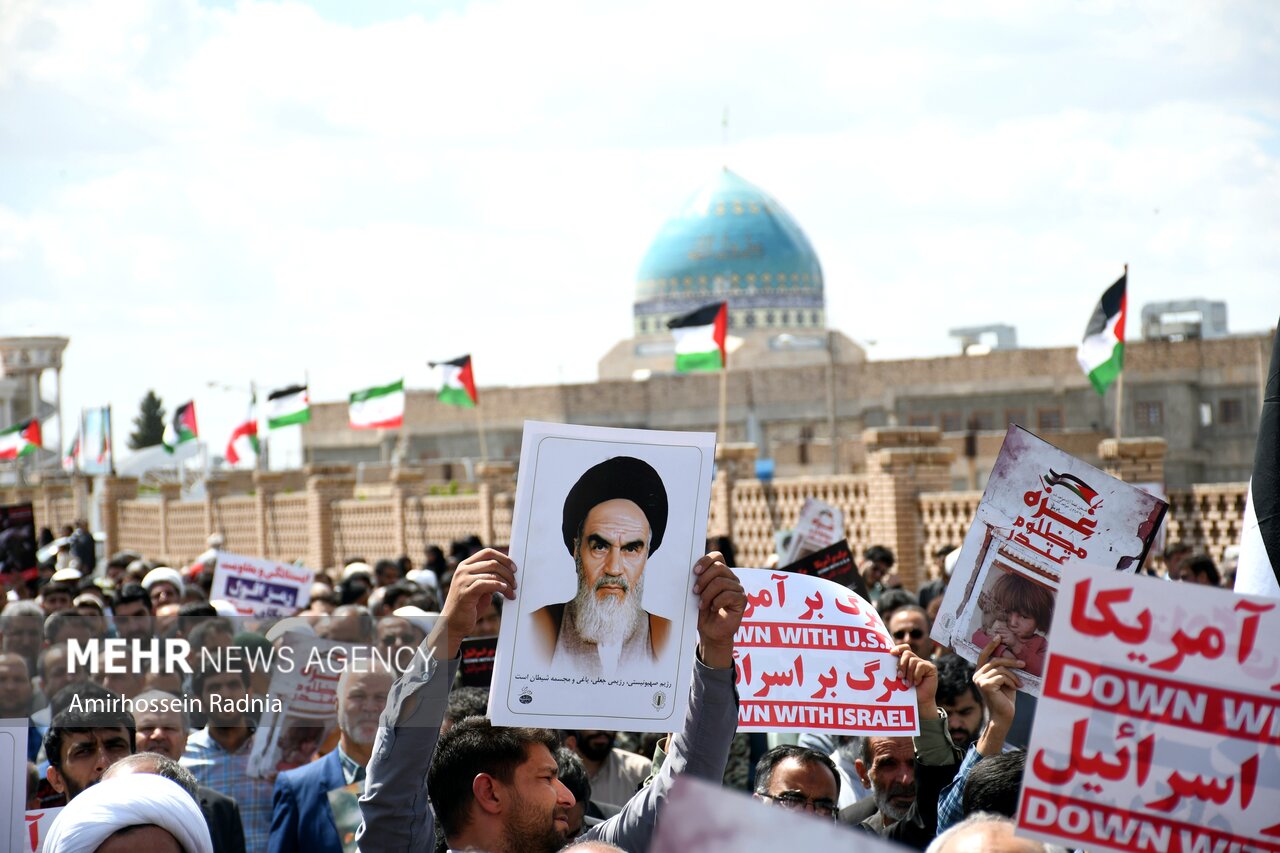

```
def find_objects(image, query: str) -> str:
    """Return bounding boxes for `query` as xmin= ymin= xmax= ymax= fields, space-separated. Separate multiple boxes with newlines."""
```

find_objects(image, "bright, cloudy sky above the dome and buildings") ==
xmin=0 ymin=0 xmax=1280 ymax=466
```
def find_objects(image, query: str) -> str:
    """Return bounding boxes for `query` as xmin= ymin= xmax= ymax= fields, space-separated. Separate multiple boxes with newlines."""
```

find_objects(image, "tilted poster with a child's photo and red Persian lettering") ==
xmin=931 ymin=425 xmax=1169 ymax=695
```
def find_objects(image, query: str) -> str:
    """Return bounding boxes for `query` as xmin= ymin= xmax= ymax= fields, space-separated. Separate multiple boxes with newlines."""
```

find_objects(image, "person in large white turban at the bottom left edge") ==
xmin=45 ymin=774 xmax=214 ymax=853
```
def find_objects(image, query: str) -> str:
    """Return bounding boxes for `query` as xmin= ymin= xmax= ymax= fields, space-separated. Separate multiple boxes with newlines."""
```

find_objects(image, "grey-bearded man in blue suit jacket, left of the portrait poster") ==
xmin=268 ymin=662 xmax=393 ymax=853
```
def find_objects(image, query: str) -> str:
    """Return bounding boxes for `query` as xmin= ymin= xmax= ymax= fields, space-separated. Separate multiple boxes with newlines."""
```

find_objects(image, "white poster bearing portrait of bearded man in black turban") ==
xmin=489 ymin=421 xmax=716 ymax=731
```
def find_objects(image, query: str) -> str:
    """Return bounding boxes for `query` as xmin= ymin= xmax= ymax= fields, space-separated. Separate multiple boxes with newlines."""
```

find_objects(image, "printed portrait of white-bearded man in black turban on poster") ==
xmin=531 ymin=456 xmax=671 ymax=675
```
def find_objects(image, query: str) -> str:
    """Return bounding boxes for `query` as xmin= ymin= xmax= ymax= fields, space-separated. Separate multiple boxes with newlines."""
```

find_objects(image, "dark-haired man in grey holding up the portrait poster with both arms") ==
xmin=357 ymin=549 xmax=746 ymax=853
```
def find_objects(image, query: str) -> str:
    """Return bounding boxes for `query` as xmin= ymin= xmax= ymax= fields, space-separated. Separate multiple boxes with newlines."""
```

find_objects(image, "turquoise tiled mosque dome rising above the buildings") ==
xmin=635 ymin=169 xmax=826 ymax=337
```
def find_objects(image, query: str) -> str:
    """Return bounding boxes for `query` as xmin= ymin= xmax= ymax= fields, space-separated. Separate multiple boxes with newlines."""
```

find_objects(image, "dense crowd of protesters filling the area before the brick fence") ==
xmin=0 ymin=528 xmax=1239 ymax=853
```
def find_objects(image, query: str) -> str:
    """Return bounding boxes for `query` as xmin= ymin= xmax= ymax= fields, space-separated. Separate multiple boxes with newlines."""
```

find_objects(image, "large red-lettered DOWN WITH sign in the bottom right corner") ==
xmin=1018 ymin=569 xmax=1280 ymax=853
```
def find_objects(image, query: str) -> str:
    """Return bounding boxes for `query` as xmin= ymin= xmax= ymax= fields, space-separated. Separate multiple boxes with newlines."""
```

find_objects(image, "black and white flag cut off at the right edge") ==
xmin=1235 ymin=317 xmax=1280 ymax=598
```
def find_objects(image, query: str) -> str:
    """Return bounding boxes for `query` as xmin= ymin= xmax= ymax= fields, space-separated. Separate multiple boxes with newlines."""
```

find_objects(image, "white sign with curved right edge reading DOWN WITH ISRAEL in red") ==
xmin=733 ymin=569 xmax=920 ymax=735
